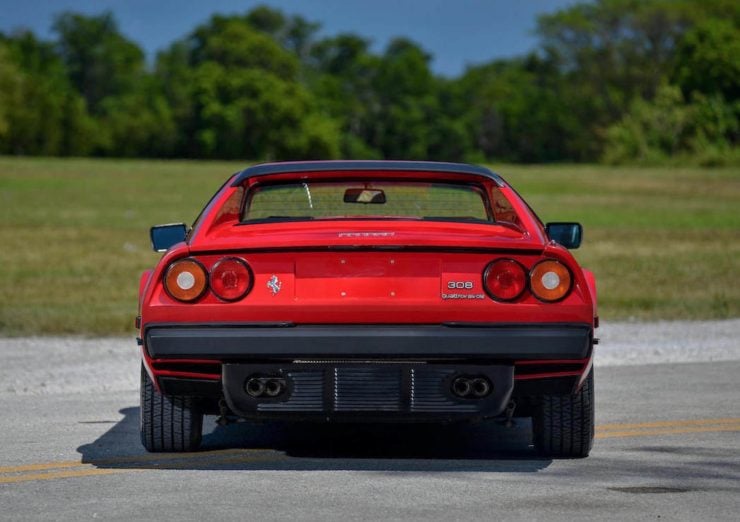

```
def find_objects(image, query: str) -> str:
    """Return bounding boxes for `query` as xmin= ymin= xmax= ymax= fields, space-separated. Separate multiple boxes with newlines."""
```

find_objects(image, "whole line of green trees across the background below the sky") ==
xmin=0 ymin=0 xmax=740 ymax=165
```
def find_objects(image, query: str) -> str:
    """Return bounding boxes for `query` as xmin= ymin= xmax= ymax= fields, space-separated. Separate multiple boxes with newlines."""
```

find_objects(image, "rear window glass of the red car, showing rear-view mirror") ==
xmin=241 ymin=181 xmax=493 ymax=223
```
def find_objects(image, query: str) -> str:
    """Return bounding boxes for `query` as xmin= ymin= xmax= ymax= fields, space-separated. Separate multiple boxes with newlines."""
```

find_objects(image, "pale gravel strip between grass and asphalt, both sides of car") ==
xmin=0 ymin=319 xmax=740 ymax=396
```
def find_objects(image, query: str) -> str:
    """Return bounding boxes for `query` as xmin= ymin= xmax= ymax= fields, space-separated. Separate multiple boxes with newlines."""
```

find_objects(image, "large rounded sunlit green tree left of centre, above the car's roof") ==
xmin=157 ymin=16 xmax=339 ymax=159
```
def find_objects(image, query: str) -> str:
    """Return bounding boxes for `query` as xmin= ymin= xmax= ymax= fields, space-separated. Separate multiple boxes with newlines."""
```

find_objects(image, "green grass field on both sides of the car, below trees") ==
xmin=0 ymin=158 xmax=740 ymax=335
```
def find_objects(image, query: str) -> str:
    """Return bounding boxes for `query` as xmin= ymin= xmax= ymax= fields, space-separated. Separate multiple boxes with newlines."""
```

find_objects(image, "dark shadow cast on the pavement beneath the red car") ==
xmin=77 ymin=407 xmax=551 ymax=473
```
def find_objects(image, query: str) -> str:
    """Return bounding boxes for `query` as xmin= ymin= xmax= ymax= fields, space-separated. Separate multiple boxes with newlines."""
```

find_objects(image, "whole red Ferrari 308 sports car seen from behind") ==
xmin=137 ymin=161 xmax=598 ymax=457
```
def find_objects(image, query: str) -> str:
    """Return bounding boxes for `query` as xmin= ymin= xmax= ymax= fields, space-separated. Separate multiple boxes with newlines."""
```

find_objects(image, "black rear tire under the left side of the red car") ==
xmin=139 ymin=365 xmax=203 ymax=452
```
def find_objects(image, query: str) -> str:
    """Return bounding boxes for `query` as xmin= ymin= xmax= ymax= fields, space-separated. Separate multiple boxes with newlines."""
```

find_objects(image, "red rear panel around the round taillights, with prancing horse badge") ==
xmin=139 ymin=251 xmax=593 ymax=324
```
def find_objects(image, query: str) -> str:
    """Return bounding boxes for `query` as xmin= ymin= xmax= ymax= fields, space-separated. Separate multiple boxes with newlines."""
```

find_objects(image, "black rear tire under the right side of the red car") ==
xmin=532 ymin=368 xmax=594 ymax=458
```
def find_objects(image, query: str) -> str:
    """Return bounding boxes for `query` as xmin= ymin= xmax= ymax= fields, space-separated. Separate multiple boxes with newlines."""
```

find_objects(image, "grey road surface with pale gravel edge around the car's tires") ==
xmin=0 ymin=321 xmax=740 ymax=520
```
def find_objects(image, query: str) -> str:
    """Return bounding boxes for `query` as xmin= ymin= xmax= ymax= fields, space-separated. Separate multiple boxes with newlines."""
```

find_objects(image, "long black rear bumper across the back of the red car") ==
xmin=144 ymin=323 xmax=592 ymax=361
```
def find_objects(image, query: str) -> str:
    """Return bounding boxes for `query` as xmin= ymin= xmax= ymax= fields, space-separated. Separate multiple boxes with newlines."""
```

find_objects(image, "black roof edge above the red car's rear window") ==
xmin=231 ymin=160 xmax=504 ymax=187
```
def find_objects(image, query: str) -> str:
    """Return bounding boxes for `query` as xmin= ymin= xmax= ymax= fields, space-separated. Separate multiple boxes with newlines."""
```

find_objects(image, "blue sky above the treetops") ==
xmin=0 ymin=0 xmax=578 ymax=76
